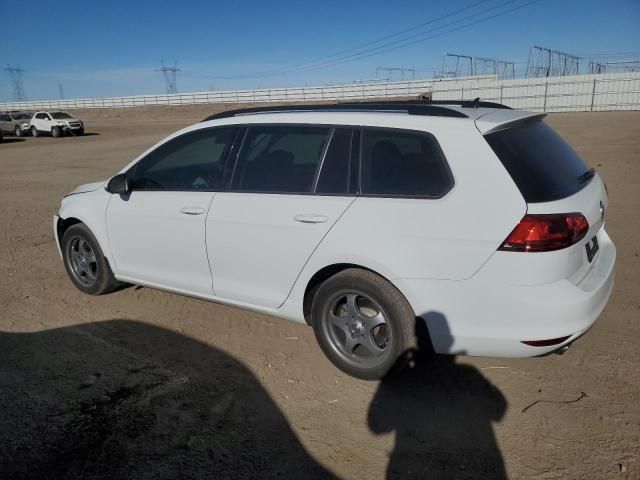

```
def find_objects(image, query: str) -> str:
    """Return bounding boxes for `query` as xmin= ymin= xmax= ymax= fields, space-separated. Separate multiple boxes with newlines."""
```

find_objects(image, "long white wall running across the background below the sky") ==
xmin=0 ymin=72 xmax=640 ymax=112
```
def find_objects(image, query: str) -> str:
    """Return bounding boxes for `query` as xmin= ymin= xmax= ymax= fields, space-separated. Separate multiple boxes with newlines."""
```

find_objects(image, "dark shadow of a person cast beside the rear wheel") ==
xmin=368 ymin=312 xmax=507 ymax=480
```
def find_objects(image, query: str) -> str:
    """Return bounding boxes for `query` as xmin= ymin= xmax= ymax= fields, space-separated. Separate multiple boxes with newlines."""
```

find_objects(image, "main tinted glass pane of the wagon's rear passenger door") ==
xmin=232 ymin=126 xmax=330 ymax=193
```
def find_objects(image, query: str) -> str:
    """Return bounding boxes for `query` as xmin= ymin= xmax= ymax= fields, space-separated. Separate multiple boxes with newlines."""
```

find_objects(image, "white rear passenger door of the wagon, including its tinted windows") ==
xmin=206 ymin=125 xmax=355 ymax=308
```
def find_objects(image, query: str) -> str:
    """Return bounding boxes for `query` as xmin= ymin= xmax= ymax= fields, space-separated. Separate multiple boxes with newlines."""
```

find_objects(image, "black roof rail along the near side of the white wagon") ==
xmin=203 ymin=100 xmax=468 ymax=122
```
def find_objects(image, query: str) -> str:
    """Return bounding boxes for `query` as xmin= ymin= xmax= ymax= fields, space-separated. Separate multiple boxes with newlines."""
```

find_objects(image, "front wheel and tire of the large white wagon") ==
xmin=61 ymin=223 xmax=120 ymax=295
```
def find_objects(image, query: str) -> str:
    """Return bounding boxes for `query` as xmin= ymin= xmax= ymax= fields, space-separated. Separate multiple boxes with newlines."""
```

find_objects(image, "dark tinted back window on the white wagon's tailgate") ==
xmin=485 ymin=121 xmax=593 ymax=203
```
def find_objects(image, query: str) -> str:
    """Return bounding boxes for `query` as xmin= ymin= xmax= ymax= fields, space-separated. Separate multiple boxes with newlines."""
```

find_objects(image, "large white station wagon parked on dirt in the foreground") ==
xmin=53 ymin=101 xmax=615 ymax=379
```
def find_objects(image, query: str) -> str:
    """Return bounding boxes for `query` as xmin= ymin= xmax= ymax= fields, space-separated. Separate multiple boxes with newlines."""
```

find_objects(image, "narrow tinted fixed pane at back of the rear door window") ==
xmin=316 ymin=128 xmax=352 ymax=193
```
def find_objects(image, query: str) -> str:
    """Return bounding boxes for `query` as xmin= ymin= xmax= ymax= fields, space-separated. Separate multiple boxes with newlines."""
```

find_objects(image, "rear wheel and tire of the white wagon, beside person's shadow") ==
xmin=311 ymin=268 xmax=417 ymax=380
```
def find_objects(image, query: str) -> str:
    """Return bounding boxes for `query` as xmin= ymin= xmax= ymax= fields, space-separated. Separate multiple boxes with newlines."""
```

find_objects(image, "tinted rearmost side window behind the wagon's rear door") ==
xmin=361 ymin=128 xmax=453 ymax=197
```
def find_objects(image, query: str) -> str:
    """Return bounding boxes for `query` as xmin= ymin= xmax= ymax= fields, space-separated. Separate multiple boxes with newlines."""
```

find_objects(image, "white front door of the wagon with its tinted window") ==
xmin=107 ymin=127 xmax=236 ymax=295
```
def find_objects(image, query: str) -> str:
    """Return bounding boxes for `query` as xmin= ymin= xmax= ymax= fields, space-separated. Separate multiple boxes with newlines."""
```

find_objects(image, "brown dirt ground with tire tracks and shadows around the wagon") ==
xmin=0 ymin=105 xmax=640 ymax=479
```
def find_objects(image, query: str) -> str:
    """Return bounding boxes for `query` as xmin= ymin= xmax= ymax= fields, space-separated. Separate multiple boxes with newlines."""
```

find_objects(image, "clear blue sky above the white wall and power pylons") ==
xmin=0 ymin=0 xmax=640 ymax=100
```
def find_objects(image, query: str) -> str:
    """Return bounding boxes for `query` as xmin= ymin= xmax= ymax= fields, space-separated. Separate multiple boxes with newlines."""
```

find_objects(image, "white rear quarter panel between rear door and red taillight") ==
xmin=282 ymin=122 xmax=527 ymax=316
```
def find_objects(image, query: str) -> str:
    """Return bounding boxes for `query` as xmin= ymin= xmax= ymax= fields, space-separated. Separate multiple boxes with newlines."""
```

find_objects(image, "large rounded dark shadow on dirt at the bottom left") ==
xmin=0 ymin=320 xmax=335 ymax=479
